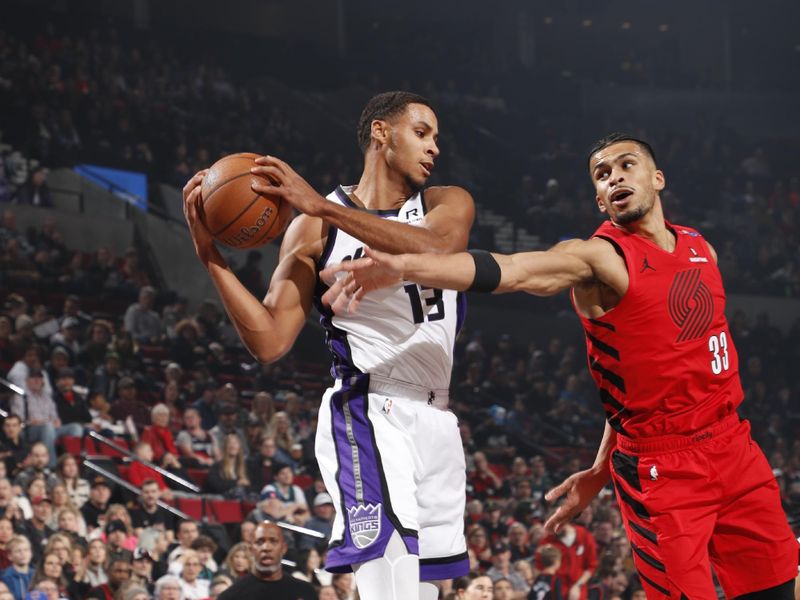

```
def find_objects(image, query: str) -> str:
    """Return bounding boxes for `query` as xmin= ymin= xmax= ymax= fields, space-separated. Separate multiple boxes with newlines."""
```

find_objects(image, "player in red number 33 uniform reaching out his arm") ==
xmin=324 ymin=134 xmax=798 ymax=600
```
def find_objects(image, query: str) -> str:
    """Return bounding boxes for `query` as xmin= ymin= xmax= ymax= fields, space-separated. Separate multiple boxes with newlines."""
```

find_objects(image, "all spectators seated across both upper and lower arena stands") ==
xmin=0 ymin=5 xmax=800 ymax=600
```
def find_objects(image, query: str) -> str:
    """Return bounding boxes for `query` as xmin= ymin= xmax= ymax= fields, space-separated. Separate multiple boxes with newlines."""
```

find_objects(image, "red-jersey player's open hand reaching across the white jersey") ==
xmin=320 ymin=248 xmax=403 ymax=314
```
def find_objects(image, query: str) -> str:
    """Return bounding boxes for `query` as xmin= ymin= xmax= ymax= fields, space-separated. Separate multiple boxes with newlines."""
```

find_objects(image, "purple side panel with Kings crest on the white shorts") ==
xmin=325 ymin=375 xmax=410 ymax=572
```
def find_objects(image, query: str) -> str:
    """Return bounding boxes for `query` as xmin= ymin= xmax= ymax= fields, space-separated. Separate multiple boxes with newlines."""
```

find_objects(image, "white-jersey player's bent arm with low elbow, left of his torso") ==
xmin=184 ymin=172 xmax=323 ymax=362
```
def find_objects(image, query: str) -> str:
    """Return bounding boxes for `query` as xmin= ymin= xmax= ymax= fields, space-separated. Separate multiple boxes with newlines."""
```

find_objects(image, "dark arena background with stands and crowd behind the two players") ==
xmin=0 ymin=0 xmax=800 ymax=600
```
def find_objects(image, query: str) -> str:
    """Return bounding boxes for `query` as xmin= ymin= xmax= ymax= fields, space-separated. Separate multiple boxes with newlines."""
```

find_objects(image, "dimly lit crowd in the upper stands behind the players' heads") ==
xmin=0 ymin=17 xmax=800 ymax=297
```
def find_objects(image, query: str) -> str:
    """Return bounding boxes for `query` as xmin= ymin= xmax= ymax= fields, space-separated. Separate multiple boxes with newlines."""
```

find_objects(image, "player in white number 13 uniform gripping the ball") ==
xmin=183 ymin=92 xmax=474 ymax=600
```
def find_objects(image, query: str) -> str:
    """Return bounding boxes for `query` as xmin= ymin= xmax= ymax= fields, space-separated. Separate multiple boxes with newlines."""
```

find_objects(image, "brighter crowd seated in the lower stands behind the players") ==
xmin=0 ymin=198 xmax=800 ymax=600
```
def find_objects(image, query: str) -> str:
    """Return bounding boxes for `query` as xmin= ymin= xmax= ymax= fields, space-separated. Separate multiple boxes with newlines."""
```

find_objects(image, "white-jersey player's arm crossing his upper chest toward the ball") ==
xmin=252 ymin=156 xmax=475 ymax=254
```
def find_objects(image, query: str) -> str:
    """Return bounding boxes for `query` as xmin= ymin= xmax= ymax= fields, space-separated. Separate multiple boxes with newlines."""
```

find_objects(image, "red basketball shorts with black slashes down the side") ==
xmin=611 ymin=415 xmax=798 ymax=600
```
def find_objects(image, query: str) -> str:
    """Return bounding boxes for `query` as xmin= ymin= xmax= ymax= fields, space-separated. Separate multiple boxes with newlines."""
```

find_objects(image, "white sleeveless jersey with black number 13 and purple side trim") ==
xmin=316 ymin=186 xmax=466 ymax=390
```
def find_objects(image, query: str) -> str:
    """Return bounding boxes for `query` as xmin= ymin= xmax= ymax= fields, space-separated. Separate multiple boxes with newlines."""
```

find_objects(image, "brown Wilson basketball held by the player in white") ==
xmin=201 ymin=152 xmax=292 ymax=248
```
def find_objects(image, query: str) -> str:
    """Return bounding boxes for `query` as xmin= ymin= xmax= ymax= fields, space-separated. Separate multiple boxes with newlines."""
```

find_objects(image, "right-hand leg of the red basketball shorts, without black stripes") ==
xmin=710 ymin=431 xmax=798 ymax=597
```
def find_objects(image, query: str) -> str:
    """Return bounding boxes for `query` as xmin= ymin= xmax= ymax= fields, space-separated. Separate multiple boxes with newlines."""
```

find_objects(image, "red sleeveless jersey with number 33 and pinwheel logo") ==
xmin=579 ymin=221 xmax=744 ymax=438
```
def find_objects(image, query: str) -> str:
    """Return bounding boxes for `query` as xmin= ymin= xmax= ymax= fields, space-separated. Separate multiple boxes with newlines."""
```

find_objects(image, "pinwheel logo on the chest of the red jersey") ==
xmin=669 ymin=269 xmax=714 ymax=342
